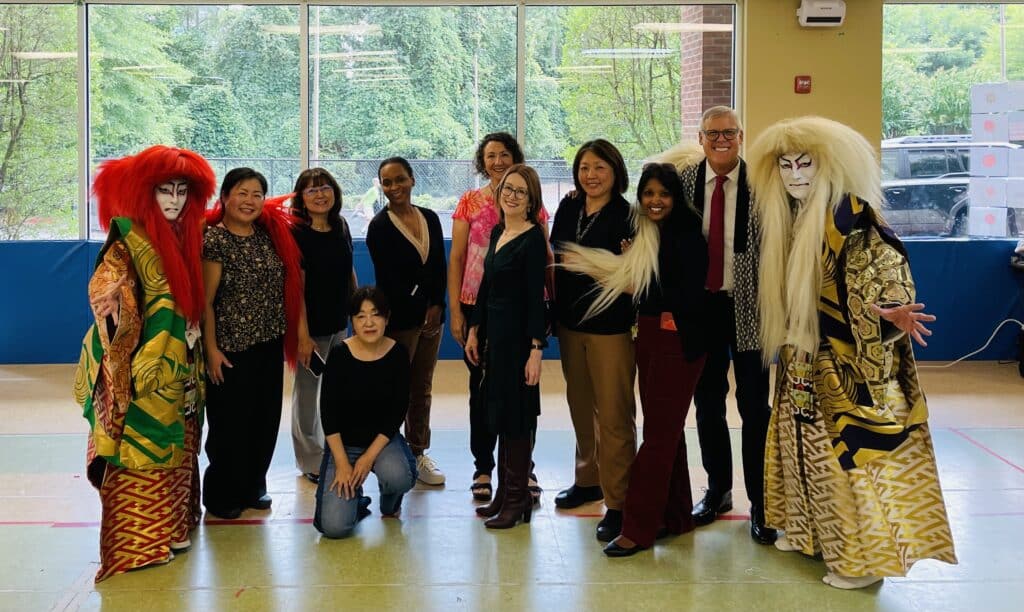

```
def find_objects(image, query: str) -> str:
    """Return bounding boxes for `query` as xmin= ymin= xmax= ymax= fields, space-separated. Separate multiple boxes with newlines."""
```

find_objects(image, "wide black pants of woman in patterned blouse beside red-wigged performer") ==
xmin=203 ymin=339 xmax=284 ymax=514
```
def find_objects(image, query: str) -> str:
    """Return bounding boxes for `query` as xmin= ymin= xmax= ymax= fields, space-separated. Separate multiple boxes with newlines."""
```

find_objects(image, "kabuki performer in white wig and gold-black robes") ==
xmin=748 ymin=117 xmax=956 ymax=588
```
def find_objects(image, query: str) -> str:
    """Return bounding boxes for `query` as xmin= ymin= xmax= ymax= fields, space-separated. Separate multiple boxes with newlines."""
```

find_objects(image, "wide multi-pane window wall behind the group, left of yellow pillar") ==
xmin=0 ymin=0 xmax=735 ymax=239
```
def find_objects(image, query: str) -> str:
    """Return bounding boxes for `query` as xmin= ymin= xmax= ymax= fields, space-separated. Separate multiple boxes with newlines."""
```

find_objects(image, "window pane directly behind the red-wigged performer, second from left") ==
xmin=88 ymin=4 xmax=299 ymax=237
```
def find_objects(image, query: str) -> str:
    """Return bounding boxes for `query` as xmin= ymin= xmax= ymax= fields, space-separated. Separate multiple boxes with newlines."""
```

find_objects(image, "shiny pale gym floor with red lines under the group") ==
xmin=0 ymin=361 xmax=1024 ymax=611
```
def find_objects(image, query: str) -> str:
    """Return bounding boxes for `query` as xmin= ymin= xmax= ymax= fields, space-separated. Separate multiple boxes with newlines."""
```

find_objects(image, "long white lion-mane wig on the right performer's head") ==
xmin=748 ymin=117 xmax=883 ymax=364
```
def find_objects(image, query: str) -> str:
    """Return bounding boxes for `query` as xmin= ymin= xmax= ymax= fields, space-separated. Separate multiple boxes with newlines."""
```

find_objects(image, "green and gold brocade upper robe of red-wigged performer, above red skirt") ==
xmin=75 ymin=218 xmax=205 ymax=470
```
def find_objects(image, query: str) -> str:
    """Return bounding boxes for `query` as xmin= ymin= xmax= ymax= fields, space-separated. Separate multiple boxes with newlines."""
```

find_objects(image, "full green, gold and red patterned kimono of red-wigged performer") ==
xmin=75 ymin=218 xmax=205 ymax=582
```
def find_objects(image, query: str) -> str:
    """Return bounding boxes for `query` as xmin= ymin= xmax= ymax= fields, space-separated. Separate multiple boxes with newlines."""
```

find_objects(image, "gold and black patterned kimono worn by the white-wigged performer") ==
xmin=765 ymin=196 xmax=956 ymax=576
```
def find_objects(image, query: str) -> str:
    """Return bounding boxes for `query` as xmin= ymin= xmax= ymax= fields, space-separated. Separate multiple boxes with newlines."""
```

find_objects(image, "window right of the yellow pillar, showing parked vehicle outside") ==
xmin=882 ymin=4 xmax=1024 ymax=236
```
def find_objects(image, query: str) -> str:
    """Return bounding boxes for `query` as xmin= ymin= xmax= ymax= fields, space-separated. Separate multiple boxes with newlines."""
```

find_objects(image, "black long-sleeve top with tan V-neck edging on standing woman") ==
xmin=367 ymin=207 xmax=447 ymax=330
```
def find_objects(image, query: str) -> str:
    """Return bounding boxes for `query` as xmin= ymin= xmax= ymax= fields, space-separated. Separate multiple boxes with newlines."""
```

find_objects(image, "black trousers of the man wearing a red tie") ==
xmin=693 ymin=292 xmax=770 ymax=507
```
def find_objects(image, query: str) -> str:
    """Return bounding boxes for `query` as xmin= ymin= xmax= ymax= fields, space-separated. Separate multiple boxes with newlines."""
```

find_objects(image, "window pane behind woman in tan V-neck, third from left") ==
xmin=309 ymin=6 xmax=516 ymax=235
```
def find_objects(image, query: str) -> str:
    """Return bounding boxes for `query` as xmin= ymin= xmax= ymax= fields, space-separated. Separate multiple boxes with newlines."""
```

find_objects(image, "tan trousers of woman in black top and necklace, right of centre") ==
xmin=558 ymin=329 xmax=637 ymax=510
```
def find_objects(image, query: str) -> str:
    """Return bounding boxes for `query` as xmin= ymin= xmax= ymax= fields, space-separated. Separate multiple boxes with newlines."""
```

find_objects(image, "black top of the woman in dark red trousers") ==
xmin=638 ymin=206 xmax=708 ymax=361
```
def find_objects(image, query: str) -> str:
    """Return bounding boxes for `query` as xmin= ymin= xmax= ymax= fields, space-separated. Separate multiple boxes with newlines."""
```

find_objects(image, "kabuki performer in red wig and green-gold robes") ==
xmin=75 ymin=145 xmax=216 ymax=582
